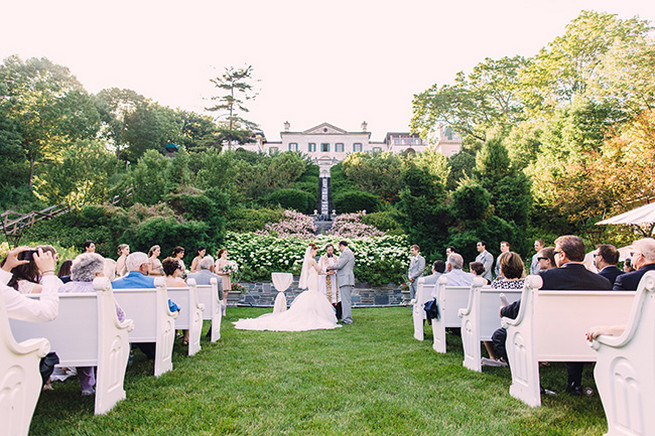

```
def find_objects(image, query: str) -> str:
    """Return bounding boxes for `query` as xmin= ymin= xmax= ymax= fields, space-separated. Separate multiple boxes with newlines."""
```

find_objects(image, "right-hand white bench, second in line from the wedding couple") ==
xmin=432 ymin=275 xmax=471 ymax=353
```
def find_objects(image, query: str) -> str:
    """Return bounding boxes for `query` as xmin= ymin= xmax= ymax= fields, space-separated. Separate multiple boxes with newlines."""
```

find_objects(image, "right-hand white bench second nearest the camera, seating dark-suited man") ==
xmin=502 ymin=276 xmax=635 ymax=407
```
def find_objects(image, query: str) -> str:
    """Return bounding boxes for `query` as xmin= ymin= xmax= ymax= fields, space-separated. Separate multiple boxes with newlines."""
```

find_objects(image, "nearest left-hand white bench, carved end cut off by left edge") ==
xmin=0 ymin=290 xmax=50 ymax=435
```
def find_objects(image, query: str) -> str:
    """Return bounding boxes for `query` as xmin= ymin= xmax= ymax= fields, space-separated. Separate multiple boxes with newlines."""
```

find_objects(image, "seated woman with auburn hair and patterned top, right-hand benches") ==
xmin=482 ymin=250 xmax=528 ymax=366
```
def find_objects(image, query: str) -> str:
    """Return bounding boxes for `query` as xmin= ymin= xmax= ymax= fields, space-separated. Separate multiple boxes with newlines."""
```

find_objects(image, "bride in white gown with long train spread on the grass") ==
xmin=234 ymin=243 xmax=341 ymax=332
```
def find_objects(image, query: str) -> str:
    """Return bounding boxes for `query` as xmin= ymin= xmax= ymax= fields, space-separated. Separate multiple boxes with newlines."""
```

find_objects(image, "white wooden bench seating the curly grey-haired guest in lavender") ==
xmin=10 ymin=277 xmax=134 ymax=415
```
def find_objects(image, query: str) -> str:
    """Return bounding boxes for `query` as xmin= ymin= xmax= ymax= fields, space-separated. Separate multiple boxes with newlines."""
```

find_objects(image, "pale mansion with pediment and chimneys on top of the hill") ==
xmin=239 ymin=122 xmax=462 ymax=177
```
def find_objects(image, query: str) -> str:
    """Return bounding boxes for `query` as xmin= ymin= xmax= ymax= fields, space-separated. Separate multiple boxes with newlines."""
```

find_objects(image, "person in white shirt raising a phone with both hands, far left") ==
xmin=0 ymin=246 xmax=63 ymax=321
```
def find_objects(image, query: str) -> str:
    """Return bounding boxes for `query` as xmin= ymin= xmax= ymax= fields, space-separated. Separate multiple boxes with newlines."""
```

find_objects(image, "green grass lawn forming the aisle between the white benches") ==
xmin=31 ymin=308 xmax=606 ymax=435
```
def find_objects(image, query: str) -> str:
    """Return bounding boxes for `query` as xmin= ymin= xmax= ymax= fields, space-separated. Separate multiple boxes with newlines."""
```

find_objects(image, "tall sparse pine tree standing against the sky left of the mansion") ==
xmin=206 ymin=65 xmax=260 ymax=144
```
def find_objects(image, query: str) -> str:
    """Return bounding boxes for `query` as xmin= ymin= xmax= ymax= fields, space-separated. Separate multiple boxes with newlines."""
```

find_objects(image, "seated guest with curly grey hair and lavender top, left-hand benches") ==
xmin=59 ymin=253 xmax=125 ymax=396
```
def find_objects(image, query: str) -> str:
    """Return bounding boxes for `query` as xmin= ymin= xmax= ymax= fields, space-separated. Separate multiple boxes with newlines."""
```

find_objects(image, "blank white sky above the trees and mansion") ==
xmin=0 ymin=0 xmax=655 ymax=141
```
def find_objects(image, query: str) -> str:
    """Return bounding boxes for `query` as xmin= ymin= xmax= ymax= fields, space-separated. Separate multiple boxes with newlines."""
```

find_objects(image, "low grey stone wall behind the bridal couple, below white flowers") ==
xmin=228 ymin=277 xmax=409 ymax=307
